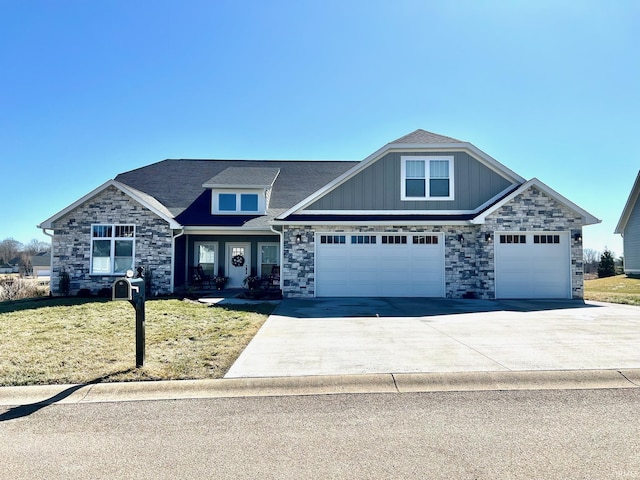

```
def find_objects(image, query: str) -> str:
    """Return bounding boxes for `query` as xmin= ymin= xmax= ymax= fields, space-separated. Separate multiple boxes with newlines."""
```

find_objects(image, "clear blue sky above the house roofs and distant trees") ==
xmin=0 ymin=0 xmax=640 ymax=255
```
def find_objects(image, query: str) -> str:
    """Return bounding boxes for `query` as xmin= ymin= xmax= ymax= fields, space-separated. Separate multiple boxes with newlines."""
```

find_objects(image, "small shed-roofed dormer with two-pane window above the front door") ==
xmin=202 ymin=167 xmax=280 ymax=215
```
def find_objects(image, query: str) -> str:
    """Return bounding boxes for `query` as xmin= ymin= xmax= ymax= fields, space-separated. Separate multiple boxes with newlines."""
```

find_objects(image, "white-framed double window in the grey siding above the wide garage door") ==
xmin=400 ymin=156 xmax=454 ymax=200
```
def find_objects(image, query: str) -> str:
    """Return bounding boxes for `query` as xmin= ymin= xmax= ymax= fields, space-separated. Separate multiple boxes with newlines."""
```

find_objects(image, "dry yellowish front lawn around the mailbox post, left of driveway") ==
xmin=0 ymin=298 xmax=273 ymax=386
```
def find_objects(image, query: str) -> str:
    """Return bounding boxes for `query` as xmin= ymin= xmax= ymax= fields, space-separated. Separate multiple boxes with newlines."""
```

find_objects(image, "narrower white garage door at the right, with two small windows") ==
xmin=495 ymin=232 xmax=571 ymax=298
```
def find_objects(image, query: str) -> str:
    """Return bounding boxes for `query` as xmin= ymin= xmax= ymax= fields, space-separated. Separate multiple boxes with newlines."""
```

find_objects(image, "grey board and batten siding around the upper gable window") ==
xmin=307 ymin=152 xmax=511 ymax=210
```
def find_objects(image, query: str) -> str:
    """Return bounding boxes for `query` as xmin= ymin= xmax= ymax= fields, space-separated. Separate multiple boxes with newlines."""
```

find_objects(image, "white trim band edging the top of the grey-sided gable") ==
xmin=277 ymin=142 xmax=525 ymax=219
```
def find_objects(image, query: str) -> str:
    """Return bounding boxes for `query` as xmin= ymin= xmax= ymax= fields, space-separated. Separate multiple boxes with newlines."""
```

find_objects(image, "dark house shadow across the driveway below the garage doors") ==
xmin=273 ymin=297 xmax=599 ymax=318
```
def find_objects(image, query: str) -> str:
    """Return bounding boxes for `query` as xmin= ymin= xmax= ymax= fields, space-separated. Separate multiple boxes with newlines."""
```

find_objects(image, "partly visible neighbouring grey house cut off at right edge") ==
xmin=615 ymin=172 xmax=640 ymax=276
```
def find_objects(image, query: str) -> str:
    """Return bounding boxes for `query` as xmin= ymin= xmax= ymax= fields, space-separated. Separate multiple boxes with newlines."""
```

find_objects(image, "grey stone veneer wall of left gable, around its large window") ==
xmin=51 ymin=187 xmax=172 ymax=295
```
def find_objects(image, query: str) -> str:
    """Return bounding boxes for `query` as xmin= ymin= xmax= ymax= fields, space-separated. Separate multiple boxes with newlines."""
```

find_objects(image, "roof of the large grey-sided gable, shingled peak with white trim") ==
xmin=277 ymin=129 xmax=525 ymax=220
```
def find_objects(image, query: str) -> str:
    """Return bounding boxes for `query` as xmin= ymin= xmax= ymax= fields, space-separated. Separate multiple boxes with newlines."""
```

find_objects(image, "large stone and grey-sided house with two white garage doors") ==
xmin=39 ymin=130 xmax=599 ymax=298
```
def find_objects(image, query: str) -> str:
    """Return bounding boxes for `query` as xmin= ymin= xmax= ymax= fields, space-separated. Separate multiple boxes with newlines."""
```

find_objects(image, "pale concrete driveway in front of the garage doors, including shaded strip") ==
xmin=225 ymin=298 xmax=640 ymax=378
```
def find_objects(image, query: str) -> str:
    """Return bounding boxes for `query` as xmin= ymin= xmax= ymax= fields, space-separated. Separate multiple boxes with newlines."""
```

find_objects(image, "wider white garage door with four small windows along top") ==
xmin=316 ymin=233 xmax=444 ymax=297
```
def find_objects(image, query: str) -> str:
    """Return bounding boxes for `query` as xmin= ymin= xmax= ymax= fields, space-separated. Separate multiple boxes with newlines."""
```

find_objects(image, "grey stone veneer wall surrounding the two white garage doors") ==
xmin=282 ymin=187 xmax=584 ymax=299
